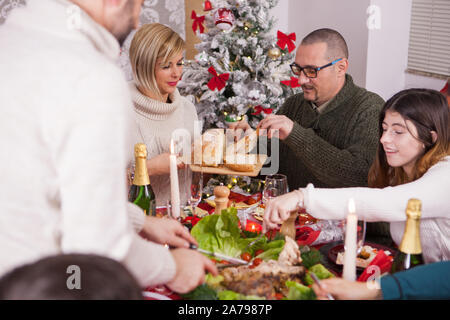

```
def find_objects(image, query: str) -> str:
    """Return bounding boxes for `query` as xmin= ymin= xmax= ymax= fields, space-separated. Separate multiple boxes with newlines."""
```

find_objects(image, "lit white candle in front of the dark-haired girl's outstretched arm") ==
xmin=342 ymin=198 xmax=358 ymax=281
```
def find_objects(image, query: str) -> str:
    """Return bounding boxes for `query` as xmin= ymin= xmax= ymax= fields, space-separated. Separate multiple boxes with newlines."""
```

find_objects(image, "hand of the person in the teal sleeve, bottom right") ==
xmin=312 ymin=278 xmax=382 ymax=300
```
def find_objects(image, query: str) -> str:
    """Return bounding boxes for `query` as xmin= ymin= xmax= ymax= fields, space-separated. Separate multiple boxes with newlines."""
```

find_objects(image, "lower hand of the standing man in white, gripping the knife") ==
xmin=167 ymin=249 xmax=219 ymax=293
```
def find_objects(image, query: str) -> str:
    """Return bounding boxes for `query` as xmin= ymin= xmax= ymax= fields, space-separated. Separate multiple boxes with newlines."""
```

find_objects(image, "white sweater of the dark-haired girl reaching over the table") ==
xmin=301 ymin=156 xmax=450 ymax=263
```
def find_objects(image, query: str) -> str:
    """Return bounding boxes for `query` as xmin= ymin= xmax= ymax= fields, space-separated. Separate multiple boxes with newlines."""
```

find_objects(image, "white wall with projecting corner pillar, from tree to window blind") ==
xmin=271 ymin=0 xmax=446 ymax=95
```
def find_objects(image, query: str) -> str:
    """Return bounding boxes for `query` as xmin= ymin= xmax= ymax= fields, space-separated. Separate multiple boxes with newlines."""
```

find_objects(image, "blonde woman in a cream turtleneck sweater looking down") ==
xmin=130 ymin=23 xmax=198 ymax=205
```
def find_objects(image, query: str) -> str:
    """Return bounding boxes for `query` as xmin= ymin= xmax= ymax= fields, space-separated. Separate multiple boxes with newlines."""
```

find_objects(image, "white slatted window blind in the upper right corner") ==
xmin=407 ymin=0 xmax=450 ymax=78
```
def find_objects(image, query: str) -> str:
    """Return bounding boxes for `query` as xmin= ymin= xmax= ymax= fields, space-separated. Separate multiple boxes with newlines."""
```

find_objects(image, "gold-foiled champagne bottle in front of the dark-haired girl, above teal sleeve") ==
xmin=391 ymin=199 xmax=424 ymax=273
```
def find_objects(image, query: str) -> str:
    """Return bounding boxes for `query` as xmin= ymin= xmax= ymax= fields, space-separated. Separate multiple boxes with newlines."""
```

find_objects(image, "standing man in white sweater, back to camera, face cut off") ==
xmin=0 ymin=0 xmax=217 ymax=292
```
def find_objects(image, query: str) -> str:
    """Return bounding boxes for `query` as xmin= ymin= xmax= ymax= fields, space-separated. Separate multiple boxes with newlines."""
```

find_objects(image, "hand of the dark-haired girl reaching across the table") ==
xmin=263 ymin=190 xmax=303 ymax=232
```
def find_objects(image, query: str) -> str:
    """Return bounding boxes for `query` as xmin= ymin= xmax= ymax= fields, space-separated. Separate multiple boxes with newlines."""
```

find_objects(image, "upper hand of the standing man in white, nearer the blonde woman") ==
xmin=140 ymin=217 xmax=197 ymax=248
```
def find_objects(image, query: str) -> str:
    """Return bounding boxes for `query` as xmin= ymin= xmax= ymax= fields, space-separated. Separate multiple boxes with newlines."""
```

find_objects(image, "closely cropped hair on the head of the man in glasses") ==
xmin=301 ymin=28 xmax=348 ymax=60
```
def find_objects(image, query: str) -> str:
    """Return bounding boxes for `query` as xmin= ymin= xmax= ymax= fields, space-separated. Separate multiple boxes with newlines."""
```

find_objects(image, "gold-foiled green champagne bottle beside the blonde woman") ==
xmin=128 ymin=143 xmax=156 ymax=216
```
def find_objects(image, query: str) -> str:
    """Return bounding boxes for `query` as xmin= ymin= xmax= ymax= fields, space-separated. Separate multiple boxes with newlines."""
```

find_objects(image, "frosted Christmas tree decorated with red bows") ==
xmin=178 ymin=0 xmax=299 ymax=130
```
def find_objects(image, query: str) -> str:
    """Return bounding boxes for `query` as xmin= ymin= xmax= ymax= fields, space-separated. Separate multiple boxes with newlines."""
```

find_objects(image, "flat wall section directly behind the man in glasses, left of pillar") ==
xmin=288 ymin=0 xmax=370 ymax=87
